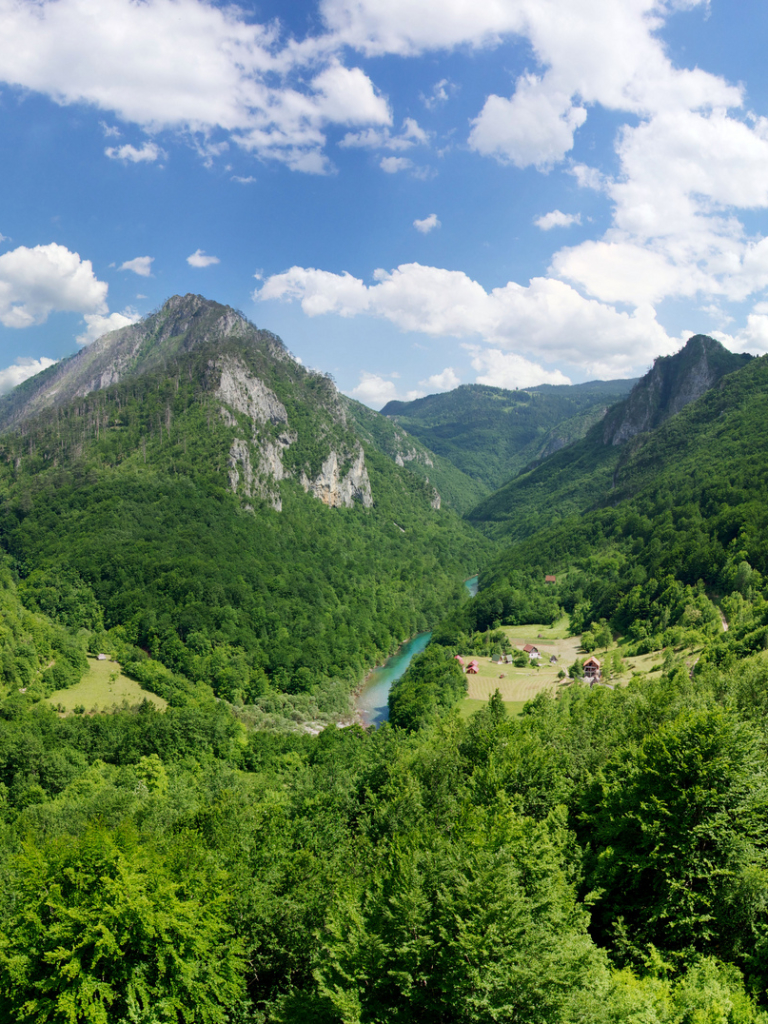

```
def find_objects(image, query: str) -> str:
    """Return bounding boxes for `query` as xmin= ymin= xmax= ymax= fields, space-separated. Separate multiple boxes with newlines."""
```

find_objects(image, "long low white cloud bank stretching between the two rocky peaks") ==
xmin=260 ymin=263 xmax=677 ymax=379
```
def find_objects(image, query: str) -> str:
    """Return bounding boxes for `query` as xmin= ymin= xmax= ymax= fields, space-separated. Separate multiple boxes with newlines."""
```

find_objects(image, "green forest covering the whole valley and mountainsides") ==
xmin=0 ymin=305 xmax=768 ymax=1024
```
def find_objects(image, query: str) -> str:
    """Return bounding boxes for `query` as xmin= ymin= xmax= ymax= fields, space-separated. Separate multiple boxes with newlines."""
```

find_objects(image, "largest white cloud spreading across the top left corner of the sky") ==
xmin=0 ymin=0 xmax=391 ymax=171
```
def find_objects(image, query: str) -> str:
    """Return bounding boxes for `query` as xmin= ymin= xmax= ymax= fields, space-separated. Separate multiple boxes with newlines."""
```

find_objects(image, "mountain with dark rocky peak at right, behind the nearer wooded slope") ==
xmin=468 ymin=335 xmax=752 ymax=540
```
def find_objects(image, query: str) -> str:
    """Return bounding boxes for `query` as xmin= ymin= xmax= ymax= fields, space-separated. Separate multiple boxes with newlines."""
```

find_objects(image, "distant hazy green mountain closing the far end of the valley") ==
xmin=382 ymin=380 xmax=635 ymax=493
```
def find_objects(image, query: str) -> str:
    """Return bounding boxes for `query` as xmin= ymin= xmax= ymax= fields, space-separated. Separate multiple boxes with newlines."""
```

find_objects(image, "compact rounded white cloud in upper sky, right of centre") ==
xmin=469 ymin=75 xmax=587 ymax=170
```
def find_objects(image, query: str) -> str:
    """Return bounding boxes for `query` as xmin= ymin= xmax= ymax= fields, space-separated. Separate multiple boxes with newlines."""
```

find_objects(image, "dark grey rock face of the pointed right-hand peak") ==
xmin=603 ymin=334 xmax=752 ymax=444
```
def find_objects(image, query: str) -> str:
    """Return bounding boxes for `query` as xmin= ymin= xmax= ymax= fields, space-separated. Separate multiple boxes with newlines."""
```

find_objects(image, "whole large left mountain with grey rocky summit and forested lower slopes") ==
xmin=0 ymin=295 xmax=488 ymax=701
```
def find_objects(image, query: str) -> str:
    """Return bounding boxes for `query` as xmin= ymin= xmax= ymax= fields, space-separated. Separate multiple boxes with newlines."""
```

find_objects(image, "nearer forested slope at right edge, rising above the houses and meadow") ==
xmin=462 ymin=348 xmax=768 ymax=659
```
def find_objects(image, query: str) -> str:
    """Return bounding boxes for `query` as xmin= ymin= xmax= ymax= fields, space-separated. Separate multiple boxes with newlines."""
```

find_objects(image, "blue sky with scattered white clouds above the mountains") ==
xmin=0 ymin=0 xmax=768 ymax=408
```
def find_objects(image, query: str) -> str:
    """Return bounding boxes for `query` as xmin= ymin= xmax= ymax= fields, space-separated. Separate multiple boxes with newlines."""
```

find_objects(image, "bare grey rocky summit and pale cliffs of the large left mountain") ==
xmin=0 ymin=295 xmax=385 ymax=511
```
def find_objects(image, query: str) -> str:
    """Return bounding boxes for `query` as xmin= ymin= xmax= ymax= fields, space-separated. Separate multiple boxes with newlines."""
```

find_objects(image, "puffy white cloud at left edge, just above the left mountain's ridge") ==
xmin=0 ymin=243 xmax=108 ymax=328
